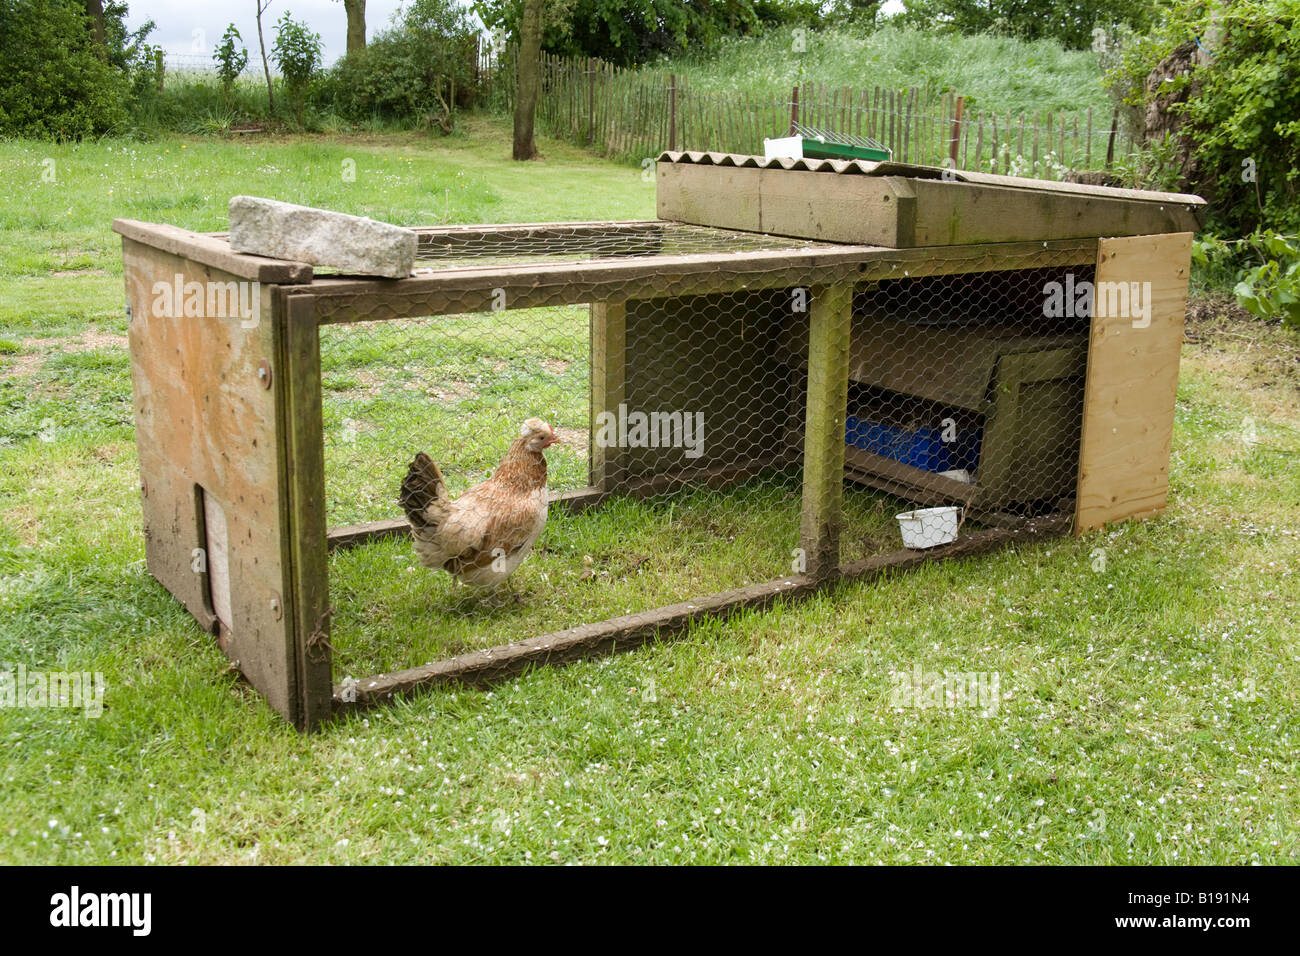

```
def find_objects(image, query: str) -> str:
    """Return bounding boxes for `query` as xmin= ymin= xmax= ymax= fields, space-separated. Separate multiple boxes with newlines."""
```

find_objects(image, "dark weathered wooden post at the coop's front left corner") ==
xmin=280 ymin=295 xmax=333 ymax=730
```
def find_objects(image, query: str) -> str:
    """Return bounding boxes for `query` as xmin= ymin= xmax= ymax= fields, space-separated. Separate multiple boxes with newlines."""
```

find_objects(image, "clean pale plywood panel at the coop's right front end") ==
xmin=1075 ymin=233 xmax=1192 ymax=535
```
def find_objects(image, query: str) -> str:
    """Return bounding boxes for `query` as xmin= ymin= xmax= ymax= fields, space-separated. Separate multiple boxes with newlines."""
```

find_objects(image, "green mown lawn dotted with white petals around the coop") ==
xmin=0 ymin=120 xmax=1300 ymax=864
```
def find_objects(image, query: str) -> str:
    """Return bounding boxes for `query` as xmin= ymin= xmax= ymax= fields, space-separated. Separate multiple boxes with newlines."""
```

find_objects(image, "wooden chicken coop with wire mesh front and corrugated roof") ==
xmin=114 ymin=152 xmax=1203 ymax=728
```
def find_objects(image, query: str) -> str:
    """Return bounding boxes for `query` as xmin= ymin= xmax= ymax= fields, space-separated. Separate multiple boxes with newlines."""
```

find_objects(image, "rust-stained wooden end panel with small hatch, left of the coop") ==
xmin=122 ymin=238 xmax=298 ymax=722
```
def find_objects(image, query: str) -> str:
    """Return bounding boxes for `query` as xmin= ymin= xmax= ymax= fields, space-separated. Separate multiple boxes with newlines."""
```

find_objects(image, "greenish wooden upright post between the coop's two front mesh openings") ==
xmin=800 ymin=282 xmax=853 ymax=579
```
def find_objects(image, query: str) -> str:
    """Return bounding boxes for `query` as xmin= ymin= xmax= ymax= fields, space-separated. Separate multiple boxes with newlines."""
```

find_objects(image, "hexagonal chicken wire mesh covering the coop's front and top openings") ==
xmin=321 ymin=230 xmax=1091 ymax=676
